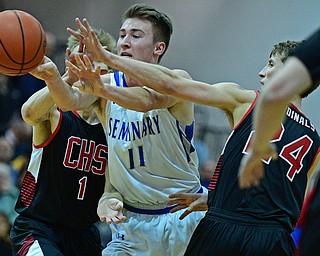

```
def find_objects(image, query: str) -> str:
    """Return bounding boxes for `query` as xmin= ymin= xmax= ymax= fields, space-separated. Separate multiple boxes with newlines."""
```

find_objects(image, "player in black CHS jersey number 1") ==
xmin=11 ymin=30 xmax=115 ymax=256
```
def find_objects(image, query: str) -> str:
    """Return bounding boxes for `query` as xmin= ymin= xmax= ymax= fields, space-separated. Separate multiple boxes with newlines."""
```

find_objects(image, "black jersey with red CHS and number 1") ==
xmin=15 ymin=111 xmax=108 ymax=227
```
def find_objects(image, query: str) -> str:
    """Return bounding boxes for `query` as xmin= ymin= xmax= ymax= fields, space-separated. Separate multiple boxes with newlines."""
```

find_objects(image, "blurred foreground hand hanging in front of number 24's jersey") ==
xmin=238 ymin=143 xmax=277 ymax=189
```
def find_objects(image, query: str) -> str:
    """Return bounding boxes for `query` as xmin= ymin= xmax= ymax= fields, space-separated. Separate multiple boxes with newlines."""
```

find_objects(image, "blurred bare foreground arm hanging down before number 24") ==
xmin=239 ymin=57 xmax=311 ymax=188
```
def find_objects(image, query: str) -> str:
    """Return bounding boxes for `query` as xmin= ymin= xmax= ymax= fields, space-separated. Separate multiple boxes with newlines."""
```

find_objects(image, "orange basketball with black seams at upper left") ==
xmin=0 ymin=10 xmax=46 ymax=76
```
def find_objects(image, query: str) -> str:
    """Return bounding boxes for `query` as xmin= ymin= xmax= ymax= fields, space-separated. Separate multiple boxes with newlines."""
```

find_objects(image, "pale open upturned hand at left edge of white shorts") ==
xmin=97 ymin=198 xmax=127 ymax=224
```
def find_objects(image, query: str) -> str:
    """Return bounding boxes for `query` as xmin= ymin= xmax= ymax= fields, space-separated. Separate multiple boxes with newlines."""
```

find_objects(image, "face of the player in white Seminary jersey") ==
xmin=117 ymin=18 xmax=158 ymax=63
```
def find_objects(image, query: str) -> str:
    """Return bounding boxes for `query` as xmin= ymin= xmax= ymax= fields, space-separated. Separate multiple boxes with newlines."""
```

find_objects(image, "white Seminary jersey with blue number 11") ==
xmin=105 ymin=72 xmax=201 ymax=208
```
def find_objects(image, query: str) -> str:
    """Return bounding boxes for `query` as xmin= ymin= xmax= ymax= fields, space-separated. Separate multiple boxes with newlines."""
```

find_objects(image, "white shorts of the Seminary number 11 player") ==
xmin=102 ymin=189 xmax=205 ymax=256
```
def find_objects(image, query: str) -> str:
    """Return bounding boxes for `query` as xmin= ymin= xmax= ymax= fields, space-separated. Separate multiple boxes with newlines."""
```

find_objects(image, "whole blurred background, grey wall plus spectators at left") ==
xmin=0 ymin=0 xmax=320 ymax=250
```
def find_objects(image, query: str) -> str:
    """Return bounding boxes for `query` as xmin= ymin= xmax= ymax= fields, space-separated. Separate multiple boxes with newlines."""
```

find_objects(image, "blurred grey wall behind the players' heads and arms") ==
xmin=0 ymin=0 xmax=320 ymax=174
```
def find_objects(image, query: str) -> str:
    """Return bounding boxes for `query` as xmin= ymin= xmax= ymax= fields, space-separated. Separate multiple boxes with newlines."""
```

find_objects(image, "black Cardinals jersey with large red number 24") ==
xmin=208 ymin=92 xmax=320 ymax=231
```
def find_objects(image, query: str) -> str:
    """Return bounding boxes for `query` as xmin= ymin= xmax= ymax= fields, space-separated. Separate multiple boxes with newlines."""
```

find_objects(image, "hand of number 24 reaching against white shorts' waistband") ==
xmin=167 ymin=193 xmax=208 ymax=220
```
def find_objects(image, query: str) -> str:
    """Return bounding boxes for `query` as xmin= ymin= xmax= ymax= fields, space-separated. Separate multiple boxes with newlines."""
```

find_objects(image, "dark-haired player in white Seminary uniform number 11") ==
xmin=33 ymin=5 xmax=206 ymax=256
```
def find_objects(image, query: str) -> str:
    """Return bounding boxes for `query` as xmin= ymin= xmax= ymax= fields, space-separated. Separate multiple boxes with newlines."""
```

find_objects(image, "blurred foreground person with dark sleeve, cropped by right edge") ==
xmin=239 ymin=30 xmax=320 ymax=256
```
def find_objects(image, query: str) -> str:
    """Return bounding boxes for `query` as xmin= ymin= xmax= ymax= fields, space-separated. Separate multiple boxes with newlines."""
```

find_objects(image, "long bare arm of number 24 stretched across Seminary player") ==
xmin=68 ymin=19 xmax=254 ymax=112
